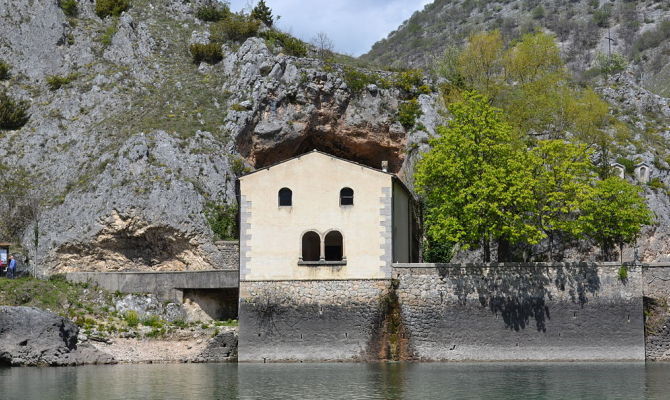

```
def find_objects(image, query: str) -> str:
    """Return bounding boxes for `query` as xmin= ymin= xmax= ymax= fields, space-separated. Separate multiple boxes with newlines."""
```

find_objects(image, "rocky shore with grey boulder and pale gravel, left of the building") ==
xmin=0 ymin=306 xmax=237 ymax=366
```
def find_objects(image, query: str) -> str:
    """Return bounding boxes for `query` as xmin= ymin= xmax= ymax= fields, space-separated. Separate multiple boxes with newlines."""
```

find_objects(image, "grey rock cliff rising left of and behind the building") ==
xmin=0 ymin=0 xmax=439 ymax=273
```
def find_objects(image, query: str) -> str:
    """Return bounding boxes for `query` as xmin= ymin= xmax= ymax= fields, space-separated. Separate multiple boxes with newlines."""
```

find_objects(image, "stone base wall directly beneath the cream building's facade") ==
xmin=239 ymin=280 xmax=389 ymax=362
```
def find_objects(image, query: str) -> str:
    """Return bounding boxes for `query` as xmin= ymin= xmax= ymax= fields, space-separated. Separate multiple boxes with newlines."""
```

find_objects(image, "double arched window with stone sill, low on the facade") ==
xmin=299 ymin=231 xmax=346 ymax=265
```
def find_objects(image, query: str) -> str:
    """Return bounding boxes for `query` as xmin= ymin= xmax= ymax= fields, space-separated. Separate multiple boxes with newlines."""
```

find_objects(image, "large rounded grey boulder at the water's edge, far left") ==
xmin=0 ymin=306 xmax=114 ymax=366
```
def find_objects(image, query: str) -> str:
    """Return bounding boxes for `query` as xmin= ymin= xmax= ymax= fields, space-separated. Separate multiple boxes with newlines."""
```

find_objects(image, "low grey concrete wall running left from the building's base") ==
xmin=65 ymin=270 xmax=239 ymax=302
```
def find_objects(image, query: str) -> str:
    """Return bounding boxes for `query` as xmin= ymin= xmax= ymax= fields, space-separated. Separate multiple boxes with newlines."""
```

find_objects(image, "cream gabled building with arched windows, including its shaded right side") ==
xmin=238 ymin=150 xmax=419 ymax=281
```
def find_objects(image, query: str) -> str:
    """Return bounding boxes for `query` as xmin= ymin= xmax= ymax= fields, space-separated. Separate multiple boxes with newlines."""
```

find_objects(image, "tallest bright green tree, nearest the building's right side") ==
xmin=415 ymin=92 xmax=542 ymax=262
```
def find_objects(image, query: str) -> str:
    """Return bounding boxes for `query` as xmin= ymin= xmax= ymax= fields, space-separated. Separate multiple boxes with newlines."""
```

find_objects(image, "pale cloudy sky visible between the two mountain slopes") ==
xmin=230 ymin=0 xmax=432 ymax=56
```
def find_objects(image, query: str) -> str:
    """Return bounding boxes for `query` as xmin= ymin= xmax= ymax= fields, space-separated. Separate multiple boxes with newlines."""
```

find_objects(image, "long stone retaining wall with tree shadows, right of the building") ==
xmin=393 ymin=263 xmax=645 ymax=361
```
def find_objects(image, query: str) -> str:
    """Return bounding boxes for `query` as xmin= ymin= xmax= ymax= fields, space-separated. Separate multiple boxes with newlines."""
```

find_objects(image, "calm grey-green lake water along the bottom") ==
xmin=0 ymin=363 xmax=670 ymax=400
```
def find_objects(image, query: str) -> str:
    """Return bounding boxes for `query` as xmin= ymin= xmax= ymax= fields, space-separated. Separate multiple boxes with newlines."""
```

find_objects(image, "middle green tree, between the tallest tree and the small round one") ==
xmin=528 ymin=140 xmax=595 ymax=261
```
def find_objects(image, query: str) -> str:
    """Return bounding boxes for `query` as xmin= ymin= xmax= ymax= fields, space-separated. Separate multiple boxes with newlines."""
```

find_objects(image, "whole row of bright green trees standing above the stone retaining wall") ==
xmin=415 ymin=92 xmax=652 ymax=262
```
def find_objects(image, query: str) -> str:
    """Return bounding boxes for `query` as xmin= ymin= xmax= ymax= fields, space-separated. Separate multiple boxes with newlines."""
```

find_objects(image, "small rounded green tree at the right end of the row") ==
xmin=580 ymin=176 xmax=653 ymax=261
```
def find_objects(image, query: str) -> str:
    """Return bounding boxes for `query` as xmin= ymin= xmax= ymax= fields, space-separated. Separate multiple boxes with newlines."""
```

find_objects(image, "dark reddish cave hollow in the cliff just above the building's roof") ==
xmin=238 ymin=133 xmax=404 ymax=173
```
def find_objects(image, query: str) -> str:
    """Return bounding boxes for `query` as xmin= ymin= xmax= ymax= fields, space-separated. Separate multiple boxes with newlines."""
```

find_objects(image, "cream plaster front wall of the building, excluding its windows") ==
xmin=240 ymin=152 xmax=392 ymax=281
